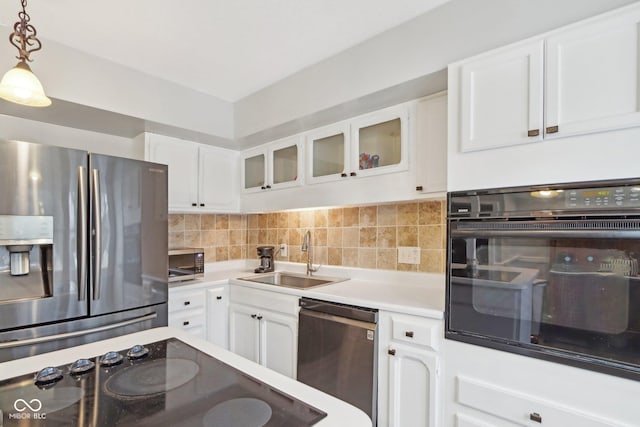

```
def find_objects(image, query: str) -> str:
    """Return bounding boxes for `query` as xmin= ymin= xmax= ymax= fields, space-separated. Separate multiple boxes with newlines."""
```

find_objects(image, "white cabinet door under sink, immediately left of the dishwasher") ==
xmin=260 ymin=311 xmax=298 ymax=378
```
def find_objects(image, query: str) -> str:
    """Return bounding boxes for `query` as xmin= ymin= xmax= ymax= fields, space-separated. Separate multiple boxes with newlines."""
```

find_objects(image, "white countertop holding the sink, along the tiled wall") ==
xmin=169 ymin=261 xmax=445 ymax=319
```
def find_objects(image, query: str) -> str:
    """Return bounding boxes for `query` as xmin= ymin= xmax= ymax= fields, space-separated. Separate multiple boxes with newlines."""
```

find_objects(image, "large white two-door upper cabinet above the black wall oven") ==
xmin=449 ymin=3 xmax=640 ymax=152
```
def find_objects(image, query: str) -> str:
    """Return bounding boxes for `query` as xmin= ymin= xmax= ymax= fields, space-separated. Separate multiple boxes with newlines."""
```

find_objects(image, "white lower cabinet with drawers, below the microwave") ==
xmin=168 ymin=283 xmax=228 ymax=348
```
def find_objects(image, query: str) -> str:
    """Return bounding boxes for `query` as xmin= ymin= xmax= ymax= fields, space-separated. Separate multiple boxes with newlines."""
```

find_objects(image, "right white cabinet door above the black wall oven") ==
xmin=545 ymin=10 xmax=640 ymax=136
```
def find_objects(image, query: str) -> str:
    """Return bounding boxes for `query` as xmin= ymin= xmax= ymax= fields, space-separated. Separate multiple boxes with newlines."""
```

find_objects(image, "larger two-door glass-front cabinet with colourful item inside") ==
xmin=305 ymin=105 xmax=409 ymax=183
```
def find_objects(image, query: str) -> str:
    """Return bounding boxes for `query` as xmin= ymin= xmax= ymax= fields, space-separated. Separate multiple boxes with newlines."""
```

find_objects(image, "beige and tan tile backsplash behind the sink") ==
xmin=169 ymin=200 xmax=446 ymax=273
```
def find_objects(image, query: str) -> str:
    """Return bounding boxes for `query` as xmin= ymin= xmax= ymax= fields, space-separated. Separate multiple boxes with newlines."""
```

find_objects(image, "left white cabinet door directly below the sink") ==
xmin=229 ymin=304 xmax=260 ymax=363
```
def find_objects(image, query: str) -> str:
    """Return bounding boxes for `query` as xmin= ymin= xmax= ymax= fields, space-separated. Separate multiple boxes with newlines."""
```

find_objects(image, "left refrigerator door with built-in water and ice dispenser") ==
xmin=0 ymin=141 xmax=88 ymax=331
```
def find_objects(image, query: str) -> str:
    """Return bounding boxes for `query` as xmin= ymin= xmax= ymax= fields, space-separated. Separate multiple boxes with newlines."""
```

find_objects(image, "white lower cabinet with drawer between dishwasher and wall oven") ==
xmin=378 ymin=311 xmax=443 ymax=427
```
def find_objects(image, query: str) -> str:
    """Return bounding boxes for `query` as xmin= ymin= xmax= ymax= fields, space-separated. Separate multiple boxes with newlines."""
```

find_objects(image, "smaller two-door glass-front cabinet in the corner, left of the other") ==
xmin=242 ymin=136 xmax=303 ymax=192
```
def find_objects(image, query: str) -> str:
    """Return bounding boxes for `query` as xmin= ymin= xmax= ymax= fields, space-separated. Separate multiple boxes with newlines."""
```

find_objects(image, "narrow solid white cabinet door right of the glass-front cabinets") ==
xmin=415 ymin=92 xmax=447 ymax=193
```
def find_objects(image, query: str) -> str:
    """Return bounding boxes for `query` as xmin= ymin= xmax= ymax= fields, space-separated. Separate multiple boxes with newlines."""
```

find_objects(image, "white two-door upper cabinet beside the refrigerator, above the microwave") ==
xmin=144 ymin=133 xmax=239 ymax=212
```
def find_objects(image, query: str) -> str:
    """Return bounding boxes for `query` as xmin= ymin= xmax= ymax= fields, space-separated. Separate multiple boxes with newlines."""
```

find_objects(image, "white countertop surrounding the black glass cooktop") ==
xmin=0 ymin=327 xmax=371 ymax=427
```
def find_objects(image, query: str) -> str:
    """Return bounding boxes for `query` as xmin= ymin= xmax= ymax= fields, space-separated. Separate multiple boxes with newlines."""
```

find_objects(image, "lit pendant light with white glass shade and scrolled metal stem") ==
xmin=0 ymin=0 xmax=51 ymax=107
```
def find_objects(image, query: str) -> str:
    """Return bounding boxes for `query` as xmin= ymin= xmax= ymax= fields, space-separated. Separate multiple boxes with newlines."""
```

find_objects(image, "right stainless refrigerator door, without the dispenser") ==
xmin=89 ymin=154 xmax=168 ymax=316
